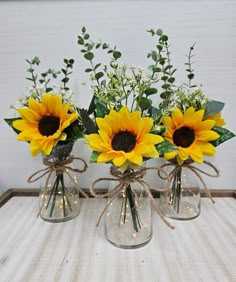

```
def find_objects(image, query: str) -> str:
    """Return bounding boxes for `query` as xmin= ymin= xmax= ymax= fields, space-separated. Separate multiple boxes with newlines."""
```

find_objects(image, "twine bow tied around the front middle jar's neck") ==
xmin=90 ymin=166 xmax=175 ymax=229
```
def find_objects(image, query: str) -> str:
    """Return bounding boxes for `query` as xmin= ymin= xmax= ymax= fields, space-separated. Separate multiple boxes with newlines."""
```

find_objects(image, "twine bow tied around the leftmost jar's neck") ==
xmin=27 ymin=156 xmax=88 ymax=215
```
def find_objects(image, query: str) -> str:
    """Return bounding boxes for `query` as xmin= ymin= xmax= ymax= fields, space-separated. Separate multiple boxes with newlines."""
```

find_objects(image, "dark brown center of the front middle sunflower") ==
xmin=111 ymin=131 xmax=136 ymax=153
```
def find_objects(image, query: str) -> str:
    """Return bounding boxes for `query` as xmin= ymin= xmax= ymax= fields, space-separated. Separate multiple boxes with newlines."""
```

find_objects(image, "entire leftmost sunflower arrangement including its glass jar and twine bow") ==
xmin=5 ymin=57 xmax=87 ymax=222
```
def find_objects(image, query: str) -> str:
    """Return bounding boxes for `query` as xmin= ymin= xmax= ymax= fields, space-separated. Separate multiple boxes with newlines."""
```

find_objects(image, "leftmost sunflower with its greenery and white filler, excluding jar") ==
xmin=5 ymin=57 xmax=84 ymax=156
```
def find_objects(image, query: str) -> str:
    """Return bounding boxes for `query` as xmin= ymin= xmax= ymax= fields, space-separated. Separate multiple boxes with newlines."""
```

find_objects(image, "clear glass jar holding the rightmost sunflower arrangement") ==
xmin=160 ymin=164 xmax=201 ymax=220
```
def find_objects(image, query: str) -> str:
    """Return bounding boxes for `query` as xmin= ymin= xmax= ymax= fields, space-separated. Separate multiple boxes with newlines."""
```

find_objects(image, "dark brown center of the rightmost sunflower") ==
xmin=173 ymin=126 xmax=195 ymax=148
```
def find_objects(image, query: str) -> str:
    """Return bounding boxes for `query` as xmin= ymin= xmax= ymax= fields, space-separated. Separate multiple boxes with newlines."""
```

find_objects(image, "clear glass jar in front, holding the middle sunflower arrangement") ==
xmin=105 ymin=166 xmax=152 ymax=249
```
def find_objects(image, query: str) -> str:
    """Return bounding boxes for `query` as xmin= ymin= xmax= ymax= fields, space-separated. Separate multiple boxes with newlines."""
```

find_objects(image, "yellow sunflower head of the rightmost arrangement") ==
xmin=162 ymin=107 xmax=219 ymax=164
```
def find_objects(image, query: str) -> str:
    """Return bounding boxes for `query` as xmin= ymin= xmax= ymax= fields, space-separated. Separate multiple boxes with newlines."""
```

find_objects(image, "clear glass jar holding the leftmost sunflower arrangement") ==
xmin=39 ymin=143 xmax=80 ymax=222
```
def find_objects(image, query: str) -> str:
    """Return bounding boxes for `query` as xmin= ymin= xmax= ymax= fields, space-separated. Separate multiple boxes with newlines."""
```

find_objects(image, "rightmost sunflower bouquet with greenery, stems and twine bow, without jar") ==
xmin=148 ymin=29 xmax=235 ymax=217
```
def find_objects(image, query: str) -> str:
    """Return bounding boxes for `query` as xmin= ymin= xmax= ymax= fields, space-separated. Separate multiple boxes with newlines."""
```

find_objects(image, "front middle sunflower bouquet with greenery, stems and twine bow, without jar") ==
xmin=78 ymin=27 xmax=176 ymax=236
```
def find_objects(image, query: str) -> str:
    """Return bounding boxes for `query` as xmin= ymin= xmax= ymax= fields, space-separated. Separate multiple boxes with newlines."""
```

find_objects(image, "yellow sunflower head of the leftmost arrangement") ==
xmin=13 ymin=93 xmax=78 ymax=156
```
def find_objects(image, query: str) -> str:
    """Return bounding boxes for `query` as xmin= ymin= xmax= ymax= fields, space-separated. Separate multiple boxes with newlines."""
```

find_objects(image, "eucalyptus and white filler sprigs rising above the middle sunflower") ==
xmin=77 ymin=27 xmax=157 ymax=125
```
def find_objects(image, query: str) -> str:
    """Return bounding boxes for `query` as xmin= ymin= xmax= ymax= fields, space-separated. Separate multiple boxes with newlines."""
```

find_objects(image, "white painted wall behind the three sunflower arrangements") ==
xmin=0 ymin=0 xmax=236 ymax=190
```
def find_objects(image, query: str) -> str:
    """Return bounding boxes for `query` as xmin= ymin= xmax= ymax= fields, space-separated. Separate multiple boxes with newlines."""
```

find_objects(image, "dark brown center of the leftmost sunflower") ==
xmin=38 ymin=116 xmax=60 ymax=136
